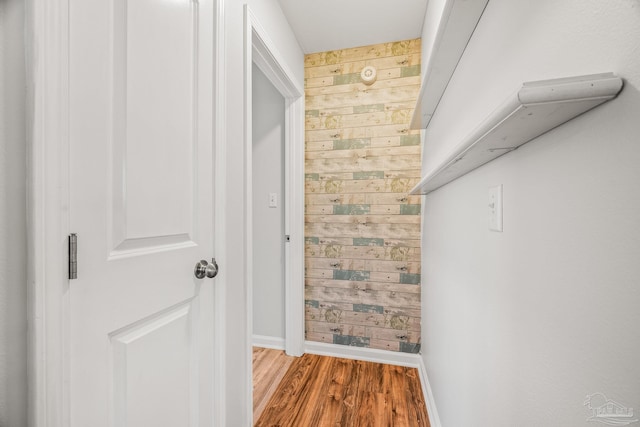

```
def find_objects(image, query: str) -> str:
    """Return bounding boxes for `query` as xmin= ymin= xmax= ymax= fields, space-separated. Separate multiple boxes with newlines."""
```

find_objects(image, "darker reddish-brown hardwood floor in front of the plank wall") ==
xmin=254 ymin=353 xmax=429 ymax=427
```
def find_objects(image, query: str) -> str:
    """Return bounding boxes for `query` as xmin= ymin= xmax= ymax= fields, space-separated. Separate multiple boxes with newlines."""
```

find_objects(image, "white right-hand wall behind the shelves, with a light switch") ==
xmin=422 ymin=0 xmax=640 ymax=427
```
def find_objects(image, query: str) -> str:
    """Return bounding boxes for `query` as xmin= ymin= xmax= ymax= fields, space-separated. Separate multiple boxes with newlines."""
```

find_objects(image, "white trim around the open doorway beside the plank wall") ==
xmin=244 ymin=5 xmax=304 ymax=362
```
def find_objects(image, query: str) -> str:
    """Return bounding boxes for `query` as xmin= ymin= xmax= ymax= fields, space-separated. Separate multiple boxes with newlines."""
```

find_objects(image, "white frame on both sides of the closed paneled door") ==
xmin=25 ymin=0 xmax=229 ymax=427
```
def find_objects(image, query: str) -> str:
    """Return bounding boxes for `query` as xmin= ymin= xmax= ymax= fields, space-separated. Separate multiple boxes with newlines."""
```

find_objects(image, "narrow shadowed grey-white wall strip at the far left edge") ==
xmin=0 ymin=0 xmax=27 ymax=427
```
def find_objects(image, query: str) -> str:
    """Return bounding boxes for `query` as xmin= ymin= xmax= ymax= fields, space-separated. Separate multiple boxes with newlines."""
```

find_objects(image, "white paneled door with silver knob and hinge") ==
xmin=67 ymin=0 xmax=215 ymax=427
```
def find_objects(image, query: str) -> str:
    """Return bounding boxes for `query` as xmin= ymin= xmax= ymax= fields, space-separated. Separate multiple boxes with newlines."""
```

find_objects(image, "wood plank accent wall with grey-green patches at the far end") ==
xmin=305 ymin=39 xmax=421 ymax=353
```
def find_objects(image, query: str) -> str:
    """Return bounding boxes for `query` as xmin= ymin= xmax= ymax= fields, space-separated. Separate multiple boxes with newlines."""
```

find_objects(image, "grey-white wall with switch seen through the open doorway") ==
xmin=252 ymin=64 xmax=285 ymax=343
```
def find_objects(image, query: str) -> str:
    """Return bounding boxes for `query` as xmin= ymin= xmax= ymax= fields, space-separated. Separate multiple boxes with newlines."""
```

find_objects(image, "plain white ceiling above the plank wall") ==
xmin=278 ymin=0 xmax=428 ymax=53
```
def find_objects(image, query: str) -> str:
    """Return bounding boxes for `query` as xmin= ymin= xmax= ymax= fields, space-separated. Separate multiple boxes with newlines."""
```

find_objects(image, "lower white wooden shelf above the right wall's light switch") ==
xmin=410 ymin=73 xmax=622 ymax=194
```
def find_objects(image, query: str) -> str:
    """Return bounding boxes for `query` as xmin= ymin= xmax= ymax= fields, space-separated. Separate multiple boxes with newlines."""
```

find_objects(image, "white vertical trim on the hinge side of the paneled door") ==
xmin=26 ymin=0 xmax=69 ymax=427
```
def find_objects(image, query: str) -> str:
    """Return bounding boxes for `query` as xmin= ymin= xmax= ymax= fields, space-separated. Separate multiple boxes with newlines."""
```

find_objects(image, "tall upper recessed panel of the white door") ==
xmin=108 ymin=0 xmax=199 ymax=259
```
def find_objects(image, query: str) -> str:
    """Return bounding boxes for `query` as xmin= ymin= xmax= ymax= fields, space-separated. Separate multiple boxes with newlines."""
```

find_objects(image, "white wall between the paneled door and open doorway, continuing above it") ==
xmin=221 ymin=0 xmax=304 ymax=426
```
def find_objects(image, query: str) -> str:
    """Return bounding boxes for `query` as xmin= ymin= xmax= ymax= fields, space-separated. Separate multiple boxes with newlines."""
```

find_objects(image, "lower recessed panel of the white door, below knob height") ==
xmin=109 ymin=298 xmax=199 ymax=426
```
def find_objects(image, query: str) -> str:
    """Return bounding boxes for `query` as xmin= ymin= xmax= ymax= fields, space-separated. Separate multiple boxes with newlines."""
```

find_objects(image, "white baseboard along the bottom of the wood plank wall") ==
xmin=304 ymin=341 xmax=422 ymax=368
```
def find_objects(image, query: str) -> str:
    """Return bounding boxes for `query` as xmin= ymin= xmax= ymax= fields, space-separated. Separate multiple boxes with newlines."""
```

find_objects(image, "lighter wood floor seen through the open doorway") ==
xmin=253 ymin=347 xmax=295 ymax=421
